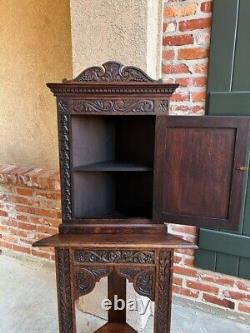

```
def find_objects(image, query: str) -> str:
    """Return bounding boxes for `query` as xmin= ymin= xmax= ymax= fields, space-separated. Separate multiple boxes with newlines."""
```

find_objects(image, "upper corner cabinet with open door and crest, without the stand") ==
xmin=48 ymin=62 xmax=250 ymax=234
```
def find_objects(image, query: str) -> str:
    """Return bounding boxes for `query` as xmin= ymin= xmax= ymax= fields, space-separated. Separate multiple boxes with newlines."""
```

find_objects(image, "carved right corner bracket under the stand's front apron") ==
xmin=116 ymin=267 xmax=155 ymax=301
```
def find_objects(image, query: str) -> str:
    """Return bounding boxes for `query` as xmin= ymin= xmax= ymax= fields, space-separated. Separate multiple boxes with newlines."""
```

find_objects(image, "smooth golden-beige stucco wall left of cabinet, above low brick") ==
xmin=0 ymin=0 xmax=72 ymax=168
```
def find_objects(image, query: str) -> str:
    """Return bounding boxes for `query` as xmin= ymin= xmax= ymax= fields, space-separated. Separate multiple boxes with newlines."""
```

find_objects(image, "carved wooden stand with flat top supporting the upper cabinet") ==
xmin=34 ymin=234 xmax=196 ymax=333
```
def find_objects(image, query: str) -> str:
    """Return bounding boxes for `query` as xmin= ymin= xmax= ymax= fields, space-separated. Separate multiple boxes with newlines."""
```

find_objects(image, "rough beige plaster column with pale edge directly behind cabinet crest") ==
xmin=71 ymin=0 xmax=163 ymax=78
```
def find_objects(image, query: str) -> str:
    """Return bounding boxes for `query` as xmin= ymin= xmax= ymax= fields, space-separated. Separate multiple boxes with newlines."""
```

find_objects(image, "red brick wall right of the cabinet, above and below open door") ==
xmin=162 ymin=0 xmax=250 ymax=314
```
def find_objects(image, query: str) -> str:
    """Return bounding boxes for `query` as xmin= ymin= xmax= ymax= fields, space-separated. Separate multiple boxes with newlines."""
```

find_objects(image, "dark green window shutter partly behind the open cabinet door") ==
xmin=195 ymin=0 xmax=250 ymax=279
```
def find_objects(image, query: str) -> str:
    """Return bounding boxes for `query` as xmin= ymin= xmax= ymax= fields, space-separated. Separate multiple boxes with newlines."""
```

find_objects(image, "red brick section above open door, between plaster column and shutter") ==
xmin=162 ymin=0 xmax=212 ymax=114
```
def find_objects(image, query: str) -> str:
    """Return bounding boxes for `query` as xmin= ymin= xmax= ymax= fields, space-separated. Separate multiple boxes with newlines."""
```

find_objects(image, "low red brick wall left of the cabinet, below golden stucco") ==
xmin=0 ymin=165 xmax=61 ymax=260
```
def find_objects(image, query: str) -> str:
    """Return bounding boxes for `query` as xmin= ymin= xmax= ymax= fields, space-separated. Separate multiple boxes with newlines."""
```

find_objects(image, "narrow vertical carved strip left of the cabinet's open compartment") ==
xmin=58 ymin=98 xmax=72 ymax=221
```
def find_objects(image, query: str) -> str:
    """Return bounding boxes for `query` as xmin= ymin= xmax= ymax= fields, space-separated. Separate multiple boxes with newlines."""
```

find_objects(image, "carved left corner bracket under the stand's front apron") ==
xmin=75 ymin=267 xmax=113 ymax=297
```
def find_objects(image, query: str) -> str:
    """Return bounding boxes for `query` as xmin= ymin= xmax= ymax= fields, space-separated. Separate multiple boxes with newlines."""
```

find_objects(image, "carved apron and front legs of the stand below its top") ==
xmin=56 ymin=248 xmax=173 ymax=333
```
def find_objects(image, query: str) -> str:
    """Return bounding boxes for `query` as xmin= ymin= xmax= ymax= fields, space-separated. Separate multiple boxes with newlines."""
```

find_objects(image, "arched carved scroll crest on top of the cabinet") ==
xmin=71 ymin=61 xmax=155 ymax=82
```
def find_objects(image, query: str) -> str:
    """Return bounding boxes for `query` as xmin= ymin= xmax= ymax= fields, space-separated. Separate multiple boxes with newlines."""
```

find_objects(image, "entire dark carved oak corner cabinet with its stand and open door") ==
xmin=34 ymin=62 xmax=249 ymax=333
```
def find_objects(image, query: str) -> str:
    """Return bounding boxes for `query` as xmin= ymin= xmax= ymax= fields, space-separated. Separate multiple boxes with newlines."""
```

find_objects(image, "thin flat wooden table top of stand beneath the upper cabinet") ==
xmin=33 ymin=234 xmax=197 ymax=249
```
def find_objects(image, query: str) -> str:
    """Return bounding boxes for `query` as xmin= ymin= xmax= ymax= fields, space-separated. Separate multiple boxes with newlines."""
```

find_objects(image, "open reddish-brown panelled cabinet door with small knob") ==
xmin=154 ymin=116 xmax=250 ymax=229
